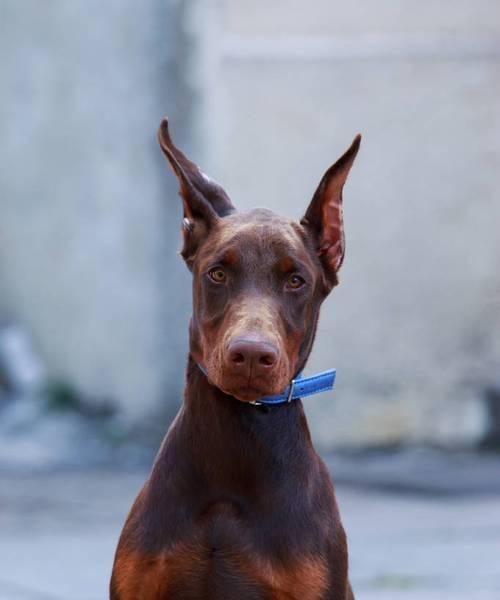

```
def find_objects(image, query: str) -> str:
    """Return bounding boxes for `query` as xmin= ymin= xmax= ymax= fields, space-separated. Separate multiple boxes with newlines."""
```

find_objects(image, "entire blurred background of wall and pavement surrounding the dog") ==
xmin=0 ymin=0 xmax=500 ymax=600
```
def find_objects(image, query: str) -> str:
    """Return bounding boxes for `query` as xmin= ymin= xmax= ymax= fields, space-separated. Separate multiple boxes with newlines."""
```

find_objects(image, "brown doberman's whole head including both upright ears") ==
xmin=159 ymin=120 xmax=360 ymax=402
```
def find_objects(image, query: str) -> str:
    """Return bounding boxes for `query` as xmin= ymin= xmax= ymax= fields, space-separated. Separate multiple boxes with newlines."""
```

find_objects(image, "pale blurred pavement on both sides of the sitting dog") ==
xmin=0 ymin=467 xmax=500 ymax=600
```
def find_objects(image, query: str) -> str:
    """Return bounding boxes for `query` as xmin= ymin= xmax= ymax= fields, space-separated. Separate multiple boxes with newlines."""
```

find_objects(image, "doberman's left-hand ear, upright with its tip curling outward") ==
xmin=158 ymin=118 xmax=235 ymax=266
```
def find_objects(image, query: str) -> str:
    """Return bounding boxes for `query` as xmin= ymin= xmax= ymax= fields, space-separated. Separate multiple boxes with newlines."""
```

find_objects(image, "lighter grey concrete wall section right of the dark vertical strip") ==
xmin=205 ymin=0 xmax=500 ymax=445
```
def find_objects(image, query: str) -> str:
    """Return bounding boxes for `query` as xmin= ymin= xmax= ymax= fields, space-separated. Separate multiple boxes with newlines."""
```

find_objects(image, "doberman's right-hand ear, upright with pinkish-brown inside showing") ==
xmin=301 ymin=134 xmax=361 ymax=286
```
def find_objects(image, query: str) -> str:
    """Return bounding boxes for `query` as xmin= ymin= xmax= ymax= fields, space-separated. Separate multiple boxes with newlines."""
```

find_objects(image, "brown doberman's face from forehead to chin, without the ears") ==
xmin=191 ymin=209 xmax=324 ymax=401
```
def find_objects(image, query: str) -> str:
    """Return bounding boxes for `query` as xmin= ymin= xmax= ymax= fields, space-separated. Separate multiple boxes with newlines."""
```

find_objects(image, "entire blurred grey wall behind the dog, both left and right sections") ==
xmin=0 ymin=0 xmax=500 ymax=446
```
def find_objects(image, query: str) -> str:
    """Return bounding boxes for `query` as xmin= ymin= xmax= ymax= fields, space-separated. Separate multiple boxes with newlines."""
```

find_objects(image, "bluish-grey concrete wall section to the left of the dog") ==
xmin=0 ymin=0 xmax=197 ymax=422
